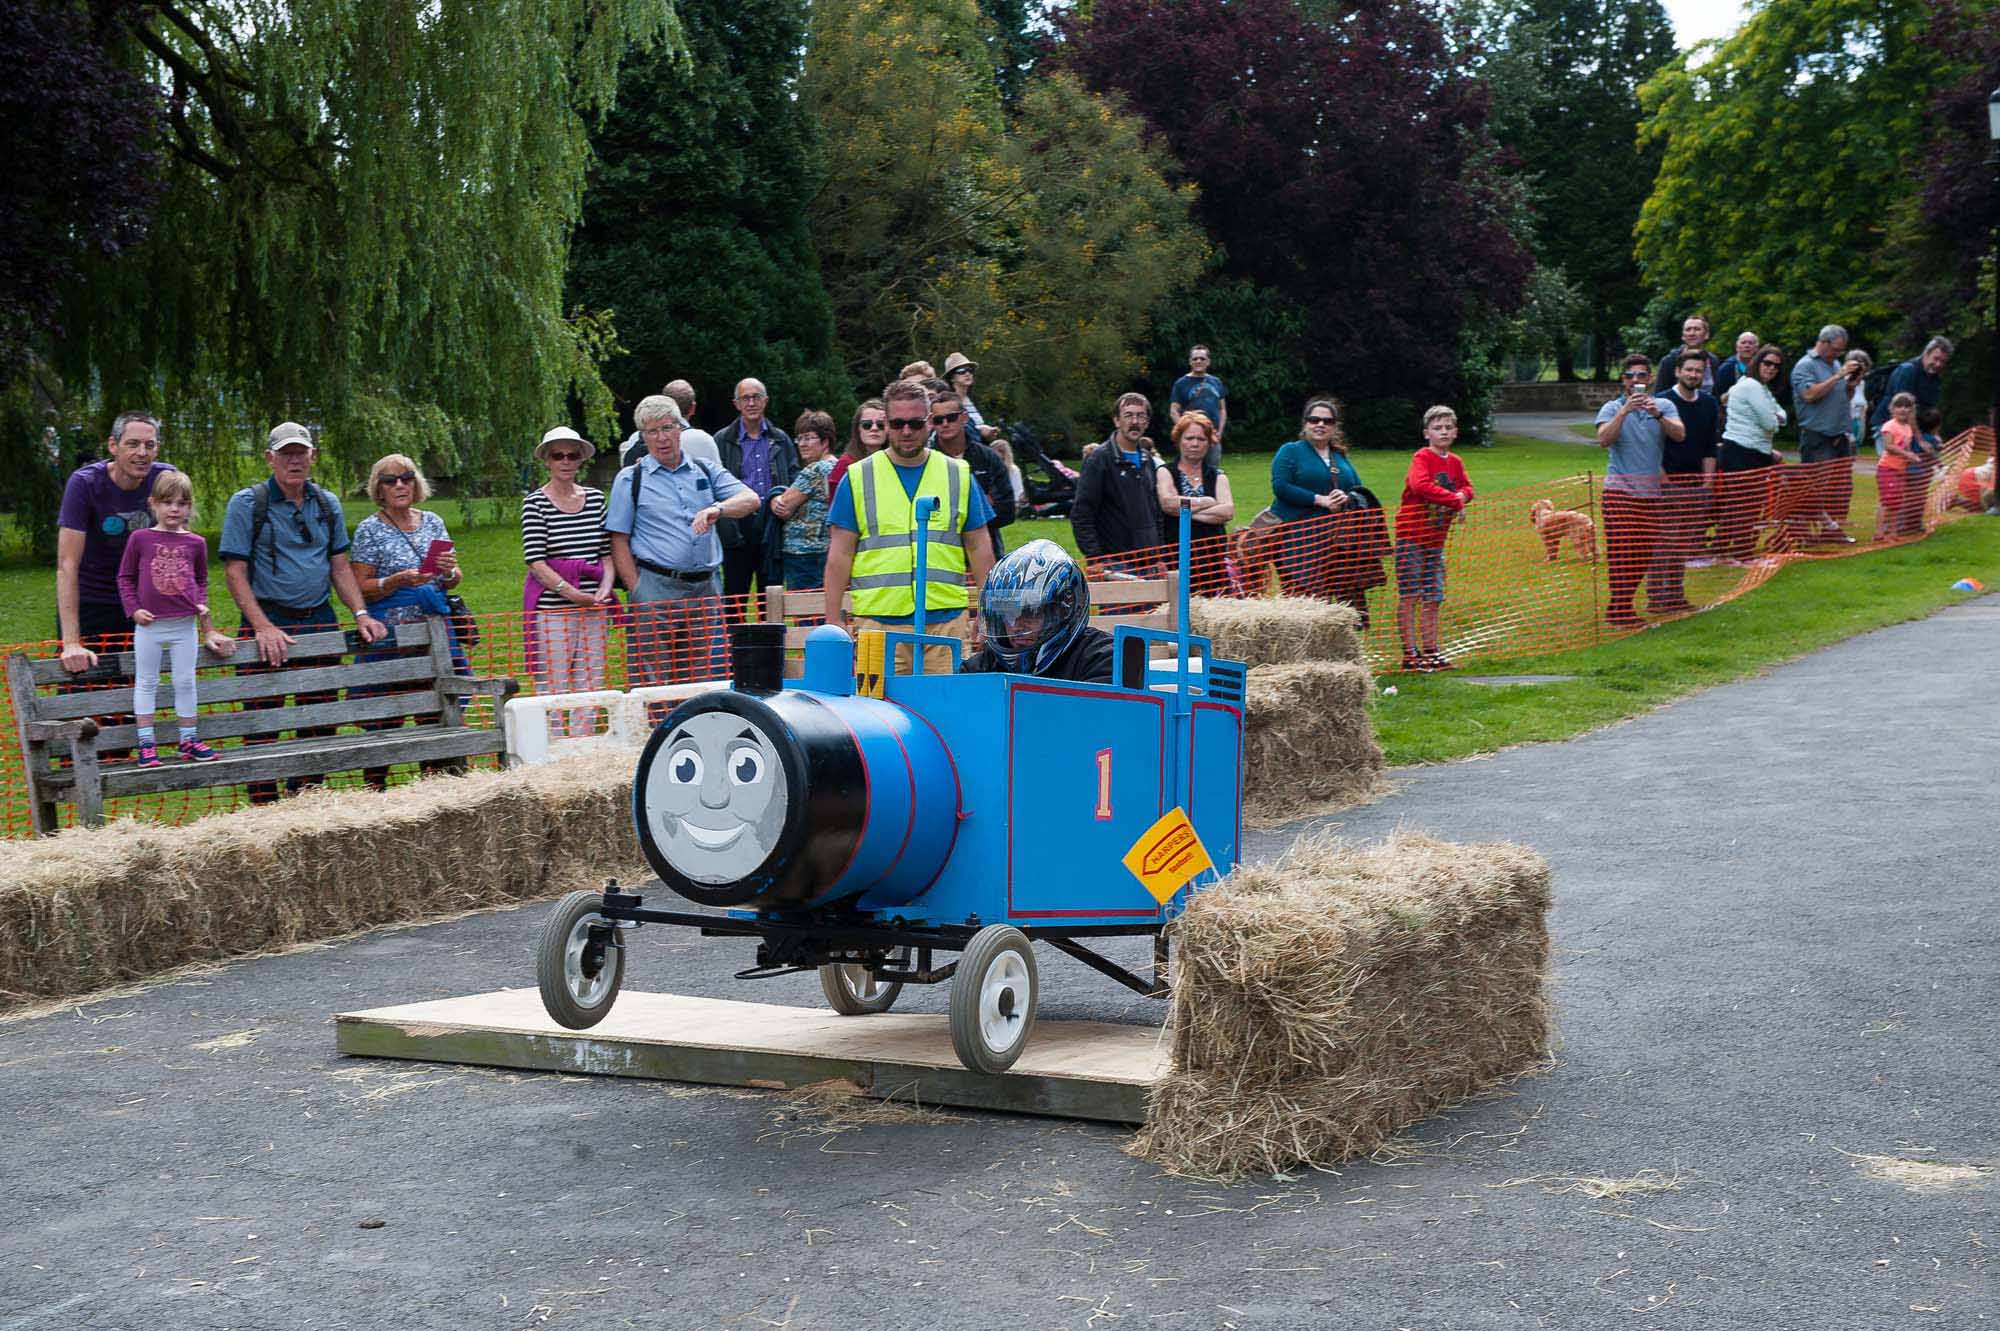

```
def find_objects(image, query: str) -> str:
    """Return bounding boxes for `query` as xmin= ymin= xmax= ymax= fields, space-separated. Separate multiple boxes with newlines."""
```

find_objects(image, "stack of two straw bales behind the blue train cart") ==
xmin=1188 ymin=596 xmax=1382 ymax=825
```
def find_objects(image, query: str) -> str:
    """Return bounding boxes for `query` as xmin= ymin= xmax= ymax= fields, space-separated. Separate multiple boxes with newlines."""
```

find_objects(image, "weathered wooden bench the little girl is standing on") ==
xmin=6 ymin=620 xmax=520 ymax=833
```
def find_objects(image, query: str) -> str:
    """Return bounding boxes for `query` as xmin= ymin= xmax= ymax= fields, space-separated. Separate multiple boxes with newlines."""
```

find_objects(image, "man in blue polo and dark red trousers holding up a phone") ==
xmin=1598 ymin=352 xmax=1688 ymax=628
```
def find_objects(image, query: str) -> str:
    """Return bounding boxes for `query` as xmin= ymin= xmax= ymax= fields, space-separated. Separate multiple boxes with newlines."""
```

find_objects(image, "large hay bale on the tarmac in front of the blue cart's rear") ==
xmin=1130 ymin=833 xmax=1550 ymax=1179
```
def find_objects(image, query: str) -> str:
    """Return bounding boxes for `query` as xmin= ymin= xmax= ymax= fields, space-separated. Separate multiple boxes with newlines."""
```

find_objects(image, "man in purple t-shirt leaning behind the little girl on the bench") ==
xmin=56 ymin=412 xmax=174 ymax=673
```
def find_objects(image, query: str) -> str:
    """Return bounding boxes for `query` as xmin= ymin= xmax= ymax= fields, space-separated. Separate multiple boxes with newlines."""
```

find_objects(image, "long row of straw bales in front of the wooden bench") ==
xmin=0 ymin=753 xmax=642 ymax=999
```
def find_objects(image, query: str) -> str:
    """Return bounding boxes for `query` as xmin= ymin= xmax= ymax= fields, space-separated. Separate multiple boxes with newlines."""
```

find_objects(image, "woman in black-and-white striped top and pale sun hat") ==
xmin=520 ymin=426 xmax=614 ymax=737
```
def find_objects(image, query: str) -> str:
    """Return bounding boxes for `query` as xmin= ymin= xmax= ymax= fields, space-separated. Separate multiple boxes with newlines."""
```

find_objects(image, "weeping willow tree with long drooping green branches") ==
xmin=46 ymin=0 xmax=682 ymax=494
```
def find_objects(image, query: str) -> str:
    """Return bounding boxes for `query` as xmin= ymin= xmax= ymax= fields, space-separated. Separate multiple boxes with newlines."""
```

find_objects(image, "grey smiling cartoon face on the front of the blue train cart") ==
xmin=646 ymin=711 xmax=790 ymax=883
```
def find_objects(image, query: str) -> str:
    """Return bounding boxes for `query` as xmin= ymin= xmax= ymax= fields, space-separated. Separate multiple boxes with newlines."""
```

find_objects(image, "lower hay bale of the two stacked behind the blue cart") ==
xmin=1244 ymin=662 xmax=1382 ymax=827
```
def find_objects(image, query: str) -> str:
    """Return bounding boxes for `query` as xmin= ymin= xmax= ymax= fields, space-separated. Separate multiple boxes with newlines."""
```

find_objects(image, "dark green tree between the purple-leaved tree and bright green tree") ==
xmin=1482 ymin=0 xmax=1674 ymax=380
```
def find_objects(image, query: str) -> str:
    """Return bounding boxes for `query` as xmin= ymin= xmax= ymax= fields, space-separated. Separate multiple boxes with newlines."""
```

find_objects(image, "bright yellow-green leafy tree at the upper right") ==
xmin=1638 ymin=0 xmax=1948 ymax=359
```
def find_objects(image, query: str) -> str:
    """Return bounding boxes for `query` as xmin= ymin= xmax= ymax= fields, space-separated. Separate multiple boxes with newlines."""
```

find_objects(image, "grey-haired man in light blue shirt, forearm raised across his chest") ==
xmin=604 ymin=398 xmax=760 ymax=687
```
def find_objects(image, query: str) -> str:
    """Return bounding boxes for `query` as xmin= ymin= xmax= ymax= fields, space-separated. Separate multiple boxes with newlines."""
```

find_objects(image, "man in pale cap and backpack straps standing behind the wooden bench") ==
xmin=220 ymin=420 xmax=388 ymax=803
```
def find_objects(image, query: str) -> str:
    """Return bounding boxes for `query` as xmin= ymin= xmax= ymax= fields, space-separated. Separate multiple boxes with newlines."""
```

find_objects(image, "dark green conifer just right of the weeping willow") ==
xmin=570 ymin=0 xmax=852 ymax=428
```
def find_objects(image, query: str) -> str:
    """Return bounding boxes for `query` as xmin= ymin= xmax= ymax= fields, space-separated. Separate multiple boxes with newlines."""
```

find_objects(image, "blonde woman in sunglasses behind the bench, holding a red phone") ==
xmin=348 ymin=454 xmax=468 ymax=789
